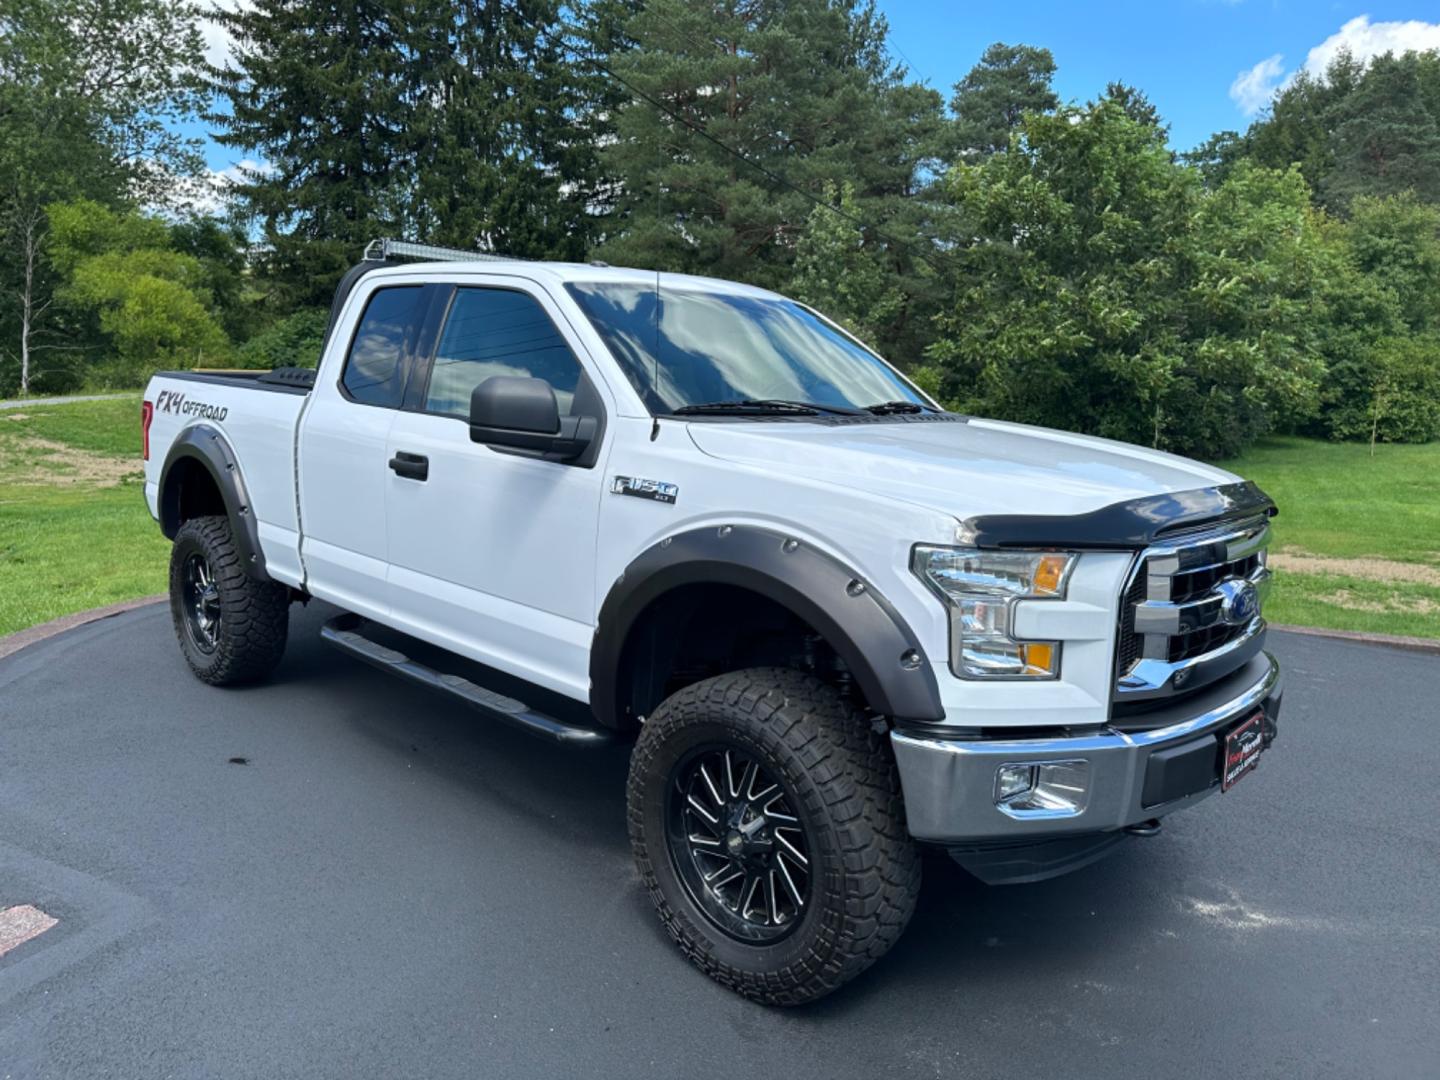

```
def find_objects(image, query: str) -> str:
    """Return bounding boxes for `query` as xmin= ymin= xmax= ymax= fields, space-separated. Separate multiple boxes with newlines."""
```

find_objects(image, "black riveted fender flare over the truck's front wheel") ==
xmin=590 ymin=526 xmax=945 ymax=727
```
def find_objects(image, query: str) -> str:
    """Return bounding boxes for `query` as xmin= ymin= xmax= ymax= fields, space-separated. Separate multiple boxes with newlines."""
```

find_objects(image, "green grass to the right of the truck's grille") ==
xmin=1220 ymin=438 xmax=1440 ymax=638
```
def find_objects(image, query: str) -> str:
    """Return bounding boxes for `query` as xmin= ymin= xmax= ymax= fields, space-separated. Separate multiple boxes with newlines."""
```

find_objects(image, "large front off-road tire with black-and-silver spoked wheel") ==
xmin=628 ymin=668 xmax=920 ymax=1005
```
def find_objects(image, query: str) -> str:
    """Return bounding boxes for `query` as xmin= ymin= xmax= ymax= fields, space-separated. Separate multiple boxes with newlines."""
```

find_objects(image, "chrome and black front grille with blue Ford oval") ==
xmin=1115 ymin=518 xmax=1269 ymax=700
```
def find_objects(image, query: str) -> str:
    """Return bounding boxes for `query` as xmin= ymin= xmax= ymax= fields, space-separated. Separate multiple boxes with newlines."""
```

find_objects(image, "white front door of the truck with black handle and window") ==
xmin=386 ymin=278 xmax=608 ymax=700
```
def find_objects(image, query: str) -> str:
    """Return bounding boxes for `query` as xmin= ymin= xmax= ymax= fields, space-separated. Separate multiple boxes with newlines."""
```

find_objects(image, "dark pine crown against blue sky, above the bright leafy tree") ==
xmin=950 ymin=42 xmax=1060 ymax=158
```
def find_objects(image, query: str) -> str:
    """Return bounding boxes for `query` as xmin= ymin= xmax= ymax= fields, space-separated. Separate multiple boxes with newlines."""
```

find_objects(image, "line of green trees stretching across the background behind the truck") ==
xmin=0 ymin=0 xmax=1440 ymax=456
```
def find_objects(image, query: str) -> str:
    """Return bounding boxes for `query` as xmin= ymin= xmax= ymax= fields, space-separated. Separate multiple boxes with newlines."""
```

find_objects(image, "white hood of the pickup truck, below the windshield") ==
xmin=690 ymin=419 xmax=1240 ymax=520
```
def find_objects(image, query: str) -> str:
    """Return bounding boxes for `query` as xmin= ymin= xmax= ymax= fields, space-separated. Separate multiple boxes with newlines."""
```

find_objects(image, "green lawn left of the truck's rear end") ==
xmin=0 ymin=395 xmax=170 ymax=634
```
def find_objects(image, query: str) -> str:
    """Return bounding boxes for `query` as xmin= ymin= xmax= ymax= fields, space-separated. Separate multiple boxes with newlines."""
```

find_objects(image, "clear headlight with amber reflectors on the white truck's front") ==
xmin=910 ymin=544 xmax=1077 ymax=678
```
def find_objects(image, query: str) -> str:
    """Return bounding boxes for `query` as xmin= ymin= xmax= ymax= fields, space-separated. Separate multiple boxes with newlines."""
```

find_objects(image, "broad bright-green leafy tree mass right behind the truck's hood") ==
xmin=930 ymin=108 xmax=1341 ymax=456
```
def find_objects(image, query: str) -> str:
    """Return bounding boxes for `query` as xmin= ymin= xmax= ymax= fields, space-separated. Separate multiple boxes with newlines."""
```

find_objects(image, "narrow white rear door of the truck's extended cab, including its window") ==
xmin=297 ymin=279 xmax=429 ymax=618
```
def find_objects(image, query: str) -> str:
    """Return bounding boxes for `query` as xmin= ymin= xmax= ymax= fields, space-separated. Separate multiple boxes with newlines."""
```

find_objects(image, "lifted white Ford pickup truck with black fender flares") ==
xmin=144 ymin=242 xmax=1280 ymax=1004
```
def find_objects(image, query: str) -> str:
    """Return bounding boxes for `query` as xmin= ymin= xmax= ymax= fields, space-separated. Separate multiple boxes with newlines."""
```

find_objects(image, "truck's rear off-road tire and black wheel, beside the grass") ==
xmin=170 ymin=516 xmax=289 ymax=687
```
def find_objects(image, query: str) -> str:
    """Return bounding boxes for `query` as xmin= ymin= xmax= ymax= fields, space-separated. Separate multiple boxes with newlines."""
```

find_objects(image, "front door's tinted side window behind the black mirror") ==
xmin=425 ymin=288 xmax=580 ymax=416
